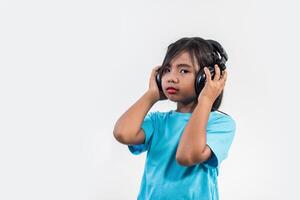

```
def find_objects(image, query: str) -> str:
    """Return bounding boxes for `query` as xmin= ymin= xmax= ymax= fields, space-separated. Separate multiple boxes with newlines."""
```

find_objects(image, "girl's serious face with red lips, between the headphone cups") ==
xmin=162 ymin=51 xmax=199 ymax=102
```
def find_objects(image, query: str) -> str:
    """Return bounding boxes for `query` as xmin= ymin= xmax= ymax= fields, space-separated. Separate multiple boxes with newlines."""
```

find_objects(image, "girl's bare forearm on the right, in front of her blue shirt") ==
xmin=176 ymin=97 xmax=212 ymax=159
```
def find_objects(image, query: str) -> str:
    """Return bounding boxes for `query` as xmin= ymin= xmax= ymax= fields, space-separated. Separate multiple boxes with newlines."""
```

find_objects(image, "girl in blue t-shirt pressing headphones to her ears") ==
xmin=113 ymin=37 xmax=236 ymax=200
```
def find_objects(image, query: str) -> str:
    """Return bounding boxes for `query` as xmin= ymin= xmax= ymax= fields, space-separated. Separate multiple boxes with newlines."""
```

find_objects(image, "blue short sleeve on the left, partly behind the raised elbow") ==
xmin=128 ymin=112 xmax=157 ymax=155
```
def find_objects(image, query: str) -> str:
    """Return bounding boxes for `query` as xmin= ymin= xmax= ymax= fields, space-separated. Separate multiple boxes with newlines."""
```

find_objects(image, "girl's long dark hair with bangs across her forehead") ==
xmin=160 ymin=37 xmax=226 ymax=114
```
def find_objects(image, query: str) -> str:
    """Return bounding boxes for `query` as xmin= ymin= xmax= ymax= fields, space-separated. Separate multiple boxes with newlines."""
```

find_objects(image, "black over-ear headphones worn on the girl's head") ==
xmin=156 ymin=40 xmax=228 ymax=97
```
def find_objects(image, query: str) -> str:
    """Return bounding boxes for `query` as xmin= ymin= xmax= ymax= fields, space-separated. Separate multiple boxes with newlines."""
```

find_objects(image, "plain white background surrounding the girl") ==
xmin=0 ymin=0 xmax=300 ymax=200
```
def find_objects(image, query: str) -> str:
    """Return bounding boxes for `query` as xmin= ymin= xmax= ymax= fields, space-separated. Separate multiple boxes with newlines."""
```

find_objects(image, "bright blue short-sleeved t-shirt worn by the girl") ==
xmin=128 ymin=110 xmax=236 ymax=200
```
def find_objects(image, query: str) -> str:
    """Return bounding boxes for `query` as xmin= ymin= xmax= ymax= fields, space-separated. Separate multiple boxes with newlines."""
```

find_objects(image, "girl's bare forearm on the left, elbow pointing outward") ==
xmin=113 ymin=92 xmax=156 ymax=138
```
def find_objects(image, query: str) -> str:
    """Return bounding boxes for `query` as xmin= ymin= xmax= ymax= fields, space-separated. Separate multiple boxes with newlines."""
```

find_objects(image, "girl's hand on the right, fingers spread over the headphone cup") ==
xmin=198 ymin=65 xmax=227 ymax=104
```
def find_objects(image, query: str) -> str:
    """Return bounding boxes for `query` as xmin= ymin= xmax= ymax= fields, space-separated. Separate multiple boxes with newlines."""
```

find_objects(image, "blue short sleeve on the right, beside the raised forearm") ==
xmin=203 ymin=115 xmax=236 ymax=168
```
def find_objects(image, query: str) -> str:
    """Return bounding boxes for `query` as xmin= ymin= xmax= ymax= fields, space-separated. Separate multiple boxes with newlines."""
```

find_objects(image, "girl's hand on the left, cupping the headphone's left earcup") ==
xmin=148 ymin=65 xmax=168 ymax=101
